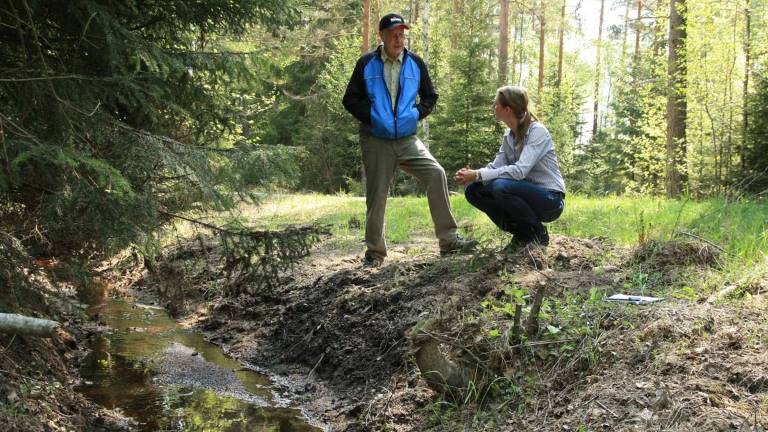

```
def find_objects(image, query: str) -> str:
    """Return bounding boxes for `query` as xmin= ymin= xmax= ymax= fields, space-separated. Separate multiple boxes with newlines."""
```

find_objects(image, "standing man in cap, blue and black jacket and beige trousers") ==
xmin=343 ymin=14 xmax=477 ymax=266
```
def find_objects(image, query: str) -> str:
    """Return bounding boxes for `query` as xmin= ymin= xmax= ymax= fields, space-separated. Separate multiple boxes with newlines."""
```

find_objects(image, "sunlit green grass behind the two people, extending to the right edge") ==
xmin=216 ymin=194 xmax=768 ymax=306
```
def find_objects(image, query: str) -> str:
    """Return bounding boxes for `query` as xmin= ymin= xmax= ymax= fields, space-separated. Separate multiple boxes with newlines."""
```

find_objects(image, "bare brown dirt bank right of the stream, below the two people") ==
xmin=137 ymin=236 xmax=768 ymax=431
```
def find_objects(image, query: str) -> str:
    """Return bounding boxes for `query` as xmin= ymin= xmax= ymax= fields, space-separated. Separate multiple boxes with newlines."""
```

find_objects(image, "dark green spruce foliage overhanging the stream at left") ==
xmin=0 ymin=0 xmax=326 ymax=288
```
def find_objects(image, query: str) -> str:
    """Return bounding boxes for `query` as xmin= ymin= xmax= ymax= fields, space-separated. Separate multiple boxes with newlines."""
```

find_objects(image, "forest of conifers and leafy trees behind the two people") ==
xmin=0 ymin=0 xmax=768 ymax=280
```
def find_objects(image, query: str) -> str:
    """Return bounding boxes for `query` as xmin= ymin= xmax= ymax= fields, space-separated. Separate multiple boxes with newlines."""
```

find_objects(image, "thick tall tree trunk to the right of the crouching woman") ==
xmin=666 ymin=0 xmax=687 ymax=197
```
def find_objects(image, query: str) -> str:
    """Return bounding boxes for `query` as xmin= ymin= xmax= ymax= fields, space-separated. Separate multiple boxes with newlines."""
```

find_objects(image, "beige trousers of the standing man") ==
xmin=360 ymin=135 xmax=456 ymax=258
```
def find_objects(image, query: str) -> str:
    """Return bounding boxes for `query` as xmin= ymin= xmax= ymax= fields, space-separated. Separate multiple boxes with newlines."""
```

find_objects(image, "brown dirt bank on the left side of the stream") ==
xmin=0 ymin=273 xmax=133 ymax=432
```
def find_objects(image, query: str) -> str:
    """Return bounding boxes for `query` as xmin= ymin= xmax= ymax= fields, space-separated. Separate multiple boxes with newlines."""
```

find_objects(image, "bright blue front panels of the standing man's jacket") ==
xmin=363 ymin=51 xmax=421 ymax=139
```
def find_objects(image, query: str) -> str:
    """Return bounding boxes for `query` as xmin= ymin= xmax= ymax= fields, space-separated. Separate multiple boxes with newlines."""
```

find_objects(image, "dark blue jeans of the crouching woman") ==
xmin=464 ymin=178 xmax=565 ymax=241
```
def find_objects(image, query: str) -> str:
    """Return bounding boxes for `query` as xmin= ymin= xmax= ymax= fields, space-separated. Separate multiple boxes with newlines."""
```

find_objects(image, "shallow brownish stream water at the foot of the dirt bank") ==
xmin=79 ymin=300 xmax=323 ymax=432
